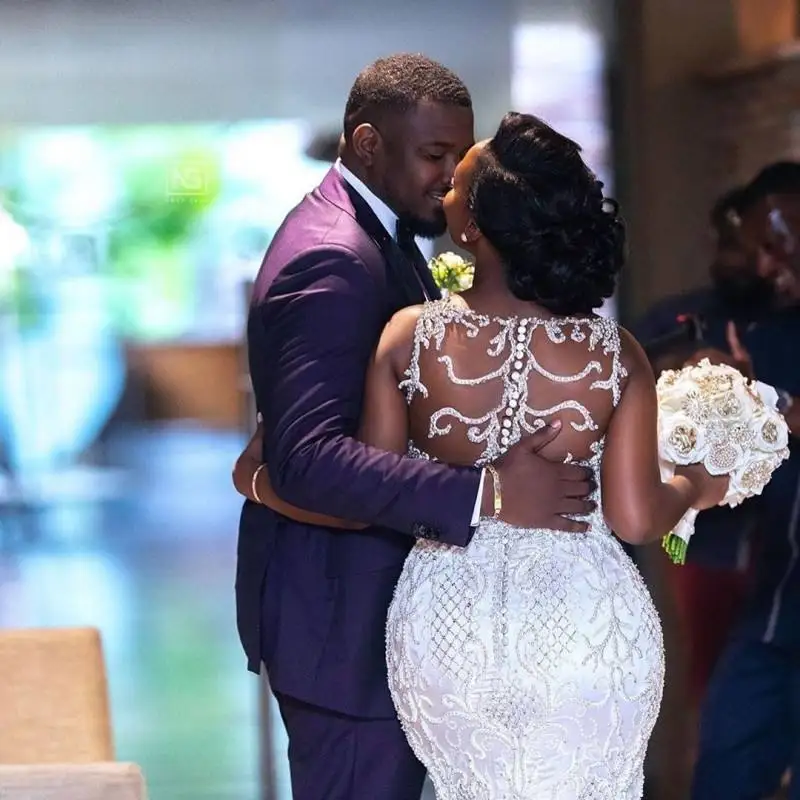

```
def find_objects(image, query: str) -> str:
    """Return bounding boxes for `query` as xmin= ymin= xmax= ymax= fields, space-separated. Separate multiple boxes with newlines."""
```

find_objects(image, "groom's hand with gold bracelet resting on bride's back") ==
xmin=482 ymin=422 xmax=596 ymax=533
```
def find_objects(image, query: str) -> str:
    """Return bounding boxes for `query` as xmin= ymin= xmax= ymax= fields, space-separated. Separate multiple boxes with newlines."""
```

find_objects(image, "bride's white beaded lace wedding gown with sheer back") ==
xmin=386 ymin=300 xmax=664 ymax=800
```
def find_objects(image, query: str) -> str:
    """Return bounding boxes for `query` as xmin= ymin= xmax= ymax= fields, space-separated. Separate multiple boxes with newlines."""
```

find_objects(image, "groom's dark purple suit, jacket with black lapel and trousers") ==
xmin=236 ymin=168 xmax=479 ymax=800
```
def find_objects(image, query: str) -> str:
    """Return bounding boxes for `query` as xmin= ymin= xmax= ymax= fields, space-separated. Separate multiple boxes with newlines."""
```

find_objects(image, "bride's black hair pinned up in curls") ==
xmin=469 ymin=113 xmax=625 ymax=314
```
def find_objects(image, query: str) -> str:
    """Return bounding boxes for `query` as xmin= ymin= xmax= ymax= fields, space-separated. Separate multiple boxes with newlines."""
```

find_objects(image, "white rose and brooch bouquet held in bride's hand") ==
xmin=656 ymin=359 xmax=789 ymax=564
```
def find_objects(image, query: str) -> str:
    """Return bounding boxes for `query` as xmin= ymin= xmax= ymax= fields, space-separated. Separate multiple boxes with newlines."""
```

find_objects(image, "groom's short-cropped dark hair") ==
xmin=344 ymin=53 xmax=472 ymax=140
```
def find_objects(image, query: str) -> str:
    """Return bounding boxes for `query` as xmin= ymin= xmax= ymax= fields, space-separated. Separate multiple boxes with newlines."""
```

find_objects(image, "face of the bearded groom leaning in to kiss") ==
xmin=374 ymin=103 xmax=474 ymax=238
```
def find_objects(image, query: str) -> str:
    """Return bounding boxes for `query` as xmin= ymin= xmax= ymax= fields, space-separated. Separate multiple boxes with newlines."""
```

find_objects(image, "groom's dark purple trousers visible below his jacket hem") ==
xmin=276 ymin=693 xmax=425 ymax=800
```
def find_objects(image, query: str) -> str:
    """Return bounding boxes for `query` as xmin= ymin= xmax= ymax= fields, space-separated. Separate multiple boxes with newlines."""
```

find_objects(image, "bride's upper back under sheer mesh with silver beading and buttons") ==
xmin=402 ymin=297 xmax=624 ymax=464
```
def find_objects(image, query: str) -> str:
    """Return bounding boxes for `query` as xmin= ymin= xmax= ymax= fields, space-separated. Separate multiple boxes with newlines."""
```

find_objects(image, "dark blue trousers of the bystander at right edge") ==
xmin=692 ymin=637 xmax=800 ymax=800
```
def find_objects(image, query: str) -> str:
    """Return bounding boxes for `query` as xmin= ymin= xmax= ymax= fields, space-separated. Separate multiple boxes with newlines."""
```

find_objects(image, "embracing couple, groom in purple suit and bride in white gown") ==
xmin=235 ymin=55 xmax=727 ymax=800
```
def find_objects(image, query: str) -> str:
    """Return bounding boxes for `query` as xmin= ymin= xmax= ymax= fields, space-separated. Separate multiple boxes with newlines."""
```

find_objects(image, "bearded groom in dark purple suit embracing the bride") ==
xmin=236 ymin=55 xmax=590 ymax=800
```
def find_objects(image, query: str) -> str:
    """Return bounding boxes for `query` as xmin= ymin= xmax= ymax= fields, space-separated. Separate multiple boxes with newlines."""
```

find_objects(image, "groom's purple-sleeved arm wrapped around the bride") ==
xmin=249 ymin=248 xmax=480 ymax=545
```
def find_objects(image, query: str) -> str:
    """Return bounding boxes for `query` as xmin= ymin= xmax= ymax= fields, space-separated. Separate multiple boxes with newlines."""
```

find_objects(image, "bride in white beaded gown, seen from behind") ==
xmin=234 ymin=114 xmax=727 ymax=800
